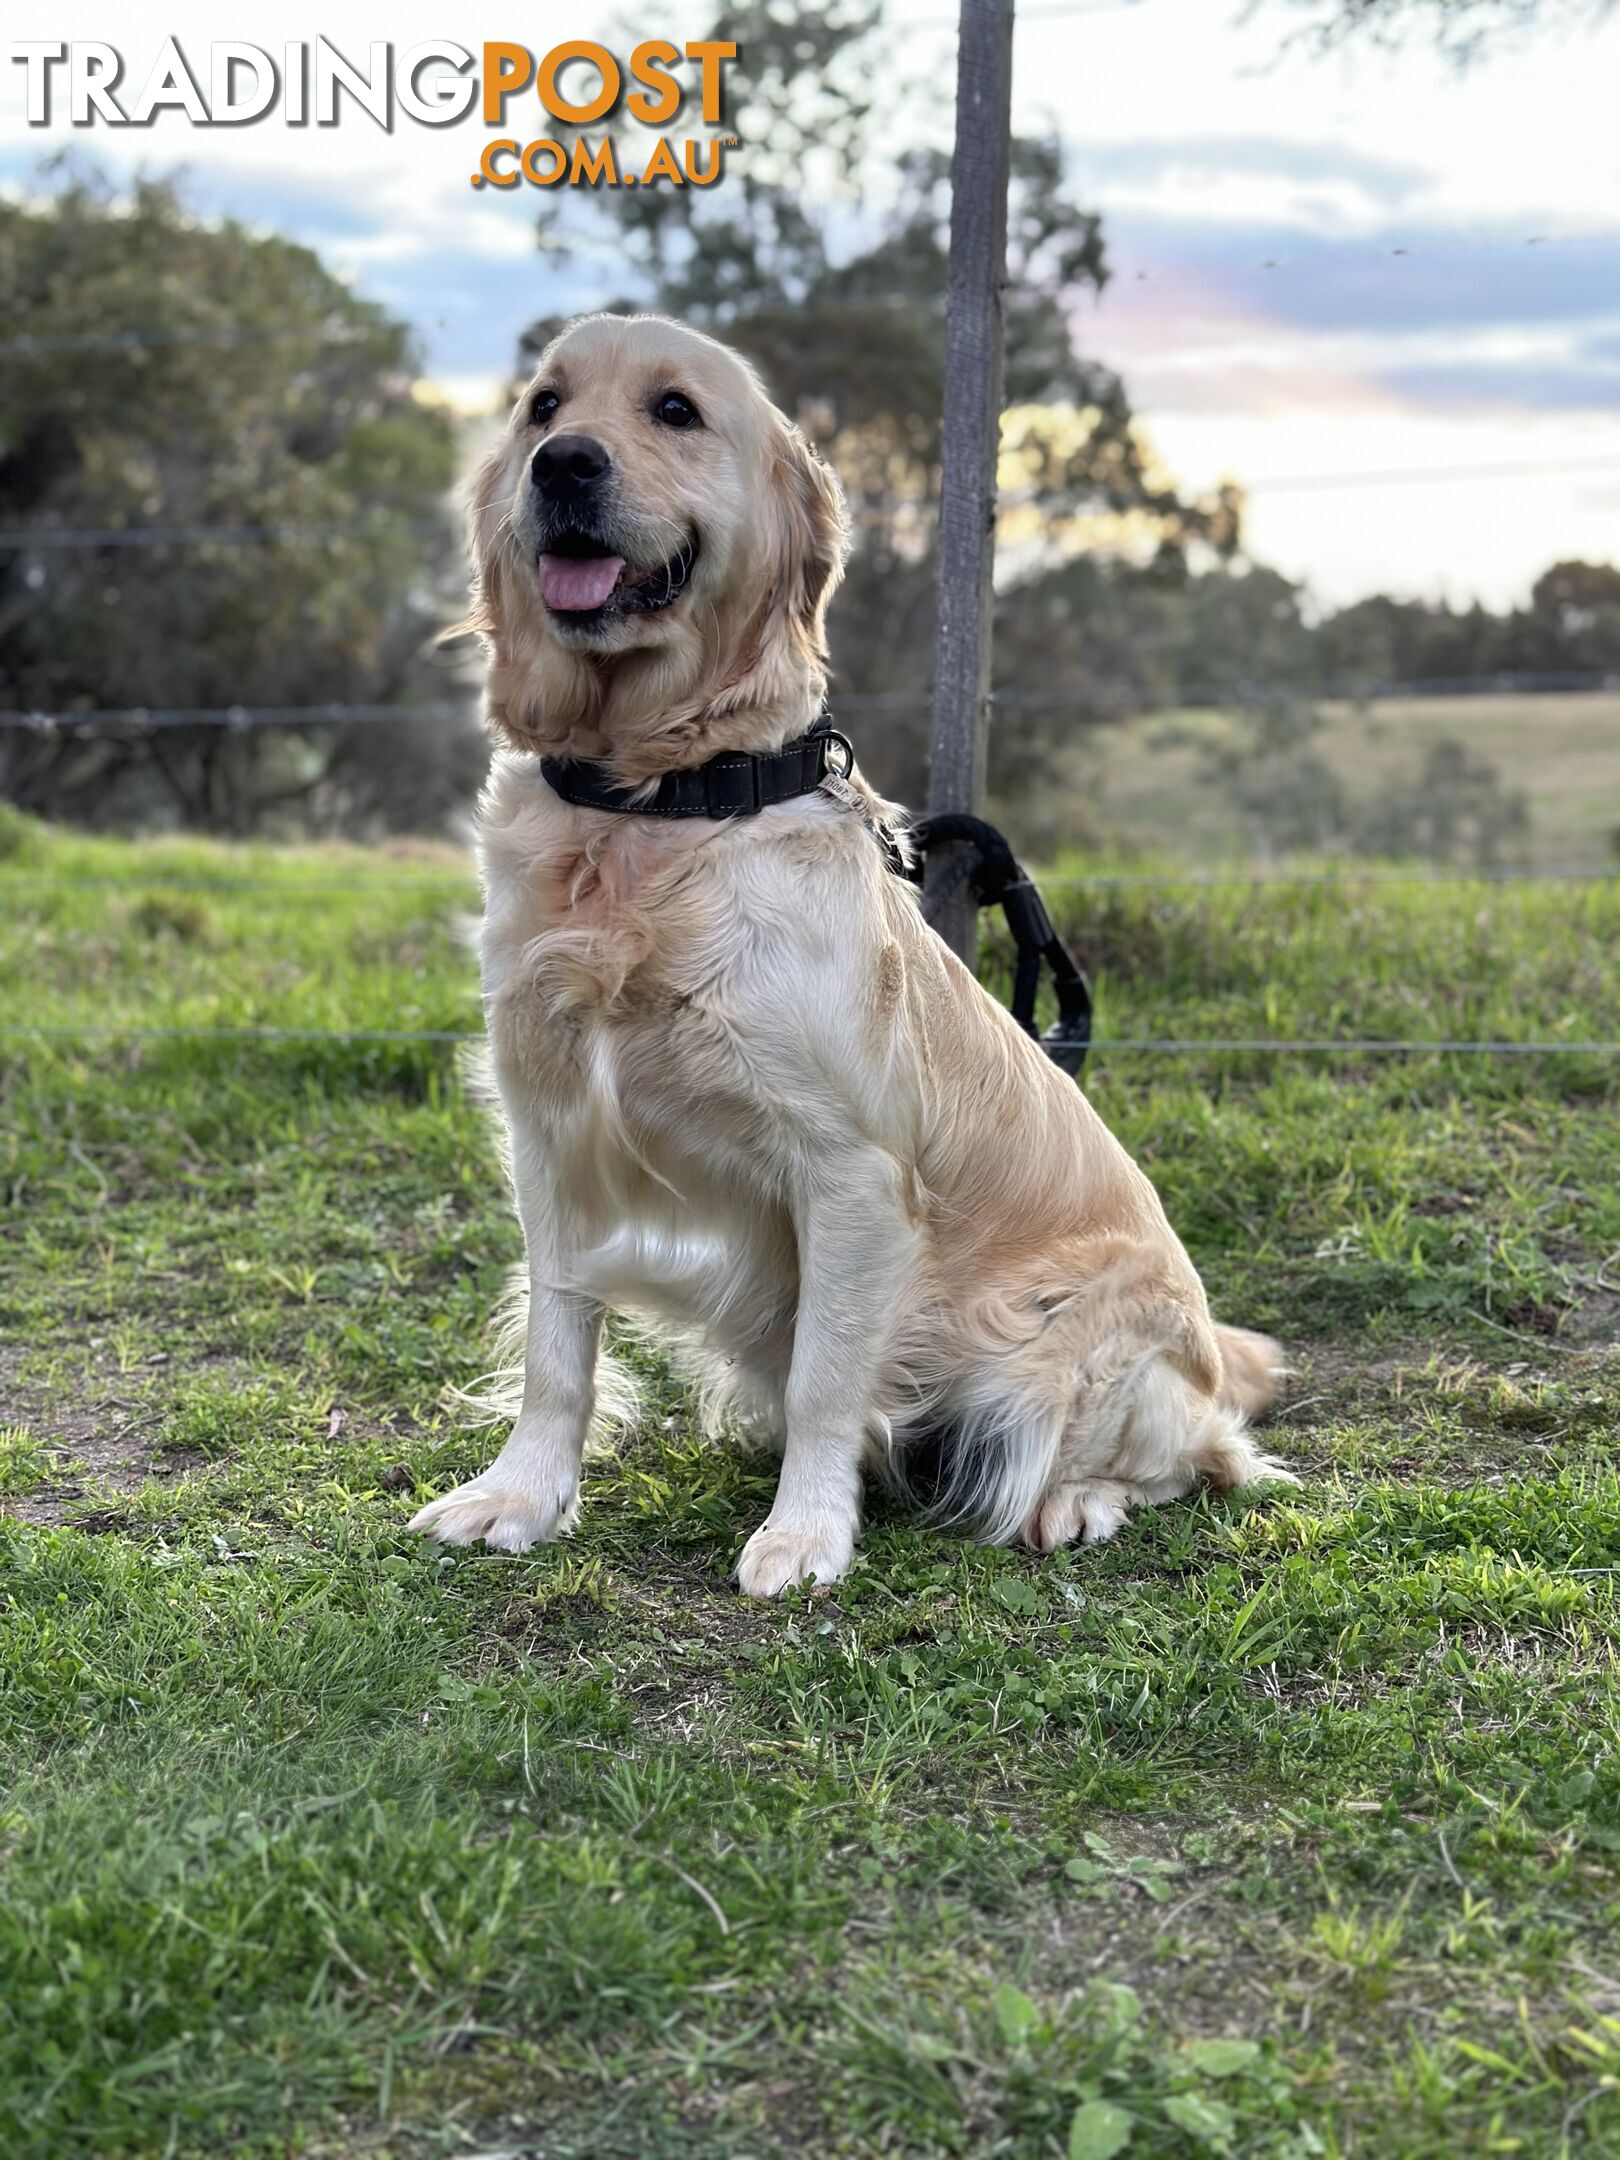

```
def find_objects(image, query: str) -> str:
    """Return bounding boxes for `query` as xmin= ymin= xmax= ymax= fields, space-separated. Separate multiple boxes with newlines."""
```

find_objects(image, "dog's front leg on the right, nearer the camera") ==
xmin=737 ymin=1149 xmax=918 ymax=1598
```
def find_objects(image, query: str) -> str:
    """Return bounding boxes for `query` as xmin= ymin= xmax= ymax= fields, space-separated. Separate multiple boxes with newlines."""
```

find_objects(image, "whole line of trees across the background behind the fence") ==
xmin=0 ymin=0 xmax=1620 ymax=845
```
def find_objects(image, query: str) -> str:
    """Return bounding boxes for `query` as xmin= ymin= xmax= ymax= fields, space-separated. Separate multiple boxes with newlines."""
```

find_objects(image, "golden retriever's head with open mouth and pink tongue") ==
xmin=471 ymin=315 xmax=845 ymax=762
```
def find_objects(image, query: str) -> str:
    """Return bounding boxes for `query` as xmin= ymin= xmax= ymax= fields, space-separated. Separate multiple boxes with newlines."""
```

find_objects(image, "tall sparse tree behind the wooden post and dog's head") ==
xmin=525 ymin=0 xmax=1240 ymax=799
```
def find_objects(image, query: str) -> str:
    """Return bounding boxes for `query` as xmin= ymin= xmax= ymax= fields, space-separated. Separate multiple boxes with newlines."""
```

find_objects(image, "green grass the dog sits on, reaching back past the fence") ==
xmin=0 ymin=823 xmax=1620 ymax=2160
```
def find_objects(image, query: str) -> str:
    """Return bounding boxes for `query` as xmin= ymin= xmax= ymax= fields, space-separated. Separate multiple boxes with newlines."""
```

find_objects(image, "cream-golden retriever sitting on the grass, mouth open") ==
xmin=413 ymin=315 xmax=1287 ymax=1598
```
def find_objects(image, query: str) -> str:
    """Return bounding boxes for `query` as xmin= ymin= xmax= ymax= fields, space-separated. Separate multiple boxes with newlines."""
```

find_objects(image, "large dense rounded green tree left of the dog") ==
xmin=0 ymin=166 xmax=475 ymax=832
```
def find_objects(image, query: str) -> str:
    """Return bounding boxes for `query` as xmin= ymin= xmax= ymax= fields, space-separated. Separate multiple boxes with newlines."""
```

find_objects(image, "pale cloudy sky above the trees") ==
xmin=0 ymin=0 xmax=1620 ymax=605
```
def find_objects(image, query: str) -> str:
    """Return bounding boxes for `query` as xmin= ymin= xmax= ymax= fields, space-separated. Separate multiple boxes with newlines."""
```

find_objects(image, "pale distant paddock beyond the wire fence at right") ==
xmin=1086 ymin=691 xmax=1620 ymax=864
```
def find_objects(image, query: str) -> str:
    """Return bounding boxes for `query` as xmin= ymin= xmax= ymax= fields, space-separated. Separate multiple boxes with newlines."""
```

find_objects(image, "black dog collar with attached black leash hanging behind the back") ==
xmin=540 ymin=704 xmax=1091 ymax=1080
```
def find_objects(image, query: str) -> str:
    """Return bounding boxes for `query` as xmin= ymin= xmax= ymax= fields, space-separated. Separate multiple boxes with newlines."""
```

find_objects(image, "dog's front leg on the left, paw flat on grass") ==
xmin=410 ymin=1261 xmax=603 ymax=1553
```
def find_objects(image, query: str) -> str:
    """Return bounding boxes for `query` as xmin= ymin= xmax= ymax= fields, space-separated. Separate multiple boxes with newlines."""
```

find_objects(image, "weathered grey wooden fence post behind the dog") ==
xmin=924 ymin=0 xmax=1013 ymax=968
